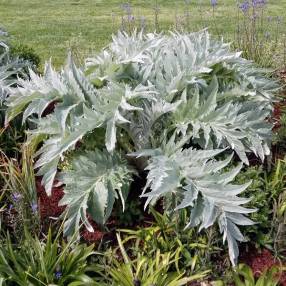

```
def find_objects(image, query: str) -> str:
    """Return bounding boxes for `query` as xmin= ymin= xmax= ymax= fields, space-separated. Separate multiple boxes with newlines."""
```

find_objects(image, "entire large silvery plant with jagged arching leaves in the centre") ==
xmin=3 ymin=30 xmax=278 ymax=264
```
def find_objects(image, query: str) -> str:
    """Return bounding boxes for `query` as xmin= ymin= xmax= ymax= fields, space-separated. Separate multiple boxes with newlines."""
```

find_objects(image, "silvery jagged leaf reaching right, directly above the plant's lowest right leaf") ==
xmin=174 ymin=77 xmax=272 ymax=164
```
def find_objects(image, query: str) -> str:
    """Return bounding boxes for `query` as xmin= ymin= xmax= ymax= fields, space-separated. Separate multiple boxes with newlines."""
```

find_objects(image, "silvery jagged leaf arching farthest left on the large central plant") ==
xmin=6 ymin=55 xmax=99 ymax=125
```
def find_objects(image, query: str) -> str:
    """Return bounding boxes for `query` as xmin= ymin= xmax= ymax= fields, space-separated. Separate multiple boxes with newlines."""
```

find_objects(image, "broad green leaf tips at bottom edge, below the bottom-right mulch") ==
xmin=233 ymin=264 xmax=281 ymax=286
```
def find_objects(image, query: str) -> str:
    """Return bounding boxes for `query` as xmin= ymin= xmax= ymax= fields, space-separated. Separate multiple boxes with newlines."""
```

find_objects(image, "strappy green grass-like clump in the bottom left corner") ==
xmin=0 ymin=230 xmax=95 ymax=286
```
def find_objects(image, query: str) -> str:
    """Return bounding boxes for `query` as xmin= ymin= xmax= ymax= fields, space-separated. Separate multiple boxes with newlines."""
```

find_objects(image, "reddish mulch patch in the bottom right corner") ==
xmin=240 ymin=247 xmax=286 ymax=286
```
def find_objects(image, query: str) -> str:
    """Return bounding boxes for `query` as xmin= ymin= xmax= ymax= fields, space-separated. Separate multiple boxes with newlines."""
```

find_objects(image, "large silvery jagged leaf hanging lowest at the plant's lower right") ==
xmin=133 ymin=136 xmax=255 ymax=265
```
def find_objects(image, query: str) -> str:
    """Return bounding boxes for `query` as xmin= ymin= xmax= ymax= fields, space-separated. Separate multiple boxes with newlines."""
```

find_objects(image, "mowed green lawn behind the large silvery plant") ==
xmin=0 ymin=0 xmax=286 ymax=67
